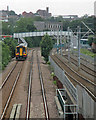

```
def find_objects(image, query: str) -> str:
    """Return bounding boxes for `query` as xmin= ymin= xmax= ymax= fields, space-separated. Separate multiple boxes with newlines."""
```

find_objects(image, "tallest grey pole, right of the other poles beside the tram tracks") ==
xmin=77 ymin=26 xmax=81 ymax=70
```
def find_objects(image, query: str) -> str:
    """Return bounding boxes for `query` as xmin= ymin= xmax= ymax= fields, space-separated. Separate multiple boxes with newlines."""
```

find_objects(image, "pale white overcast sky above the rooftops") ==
xmin=0 ymin=0 xmax=96 ymax=16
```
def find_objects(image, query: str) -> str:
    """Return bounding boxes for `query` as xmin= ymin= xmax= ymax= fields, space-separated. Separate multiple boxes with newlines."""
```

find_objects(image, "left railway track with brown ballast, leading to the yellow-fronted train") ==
xmin=0 ymin=62 xmax=24 ymax=120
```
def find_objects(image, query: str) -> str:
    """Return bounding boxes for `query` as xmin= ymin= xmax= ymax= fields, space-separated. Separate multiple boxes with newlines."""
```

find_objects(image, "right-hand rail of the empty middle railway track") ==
xmin=36 ymin=51 xmax=49 ymax=120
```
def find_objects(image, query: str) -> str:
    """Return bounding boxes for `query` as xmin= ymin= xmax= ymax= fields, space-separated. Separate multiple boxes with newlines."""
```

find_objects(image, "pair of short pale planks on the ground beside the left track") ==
xmin=10 ymin=104 xmax=22 ymax=120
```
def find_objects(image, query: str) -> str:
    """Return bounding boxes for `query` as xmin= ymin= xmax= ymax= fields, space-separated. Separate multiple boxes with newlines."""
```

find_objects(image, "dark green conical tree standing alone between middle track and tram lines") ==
xmin=41 ymin=34 xmax=53 ymax=62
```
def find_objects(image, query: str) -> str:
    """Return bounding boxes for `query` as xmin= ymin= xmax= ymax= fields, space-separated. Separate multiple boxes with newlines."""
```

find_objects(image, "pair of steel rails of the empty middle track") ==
xmin=26 ymin=50 xmax=49 ymax=120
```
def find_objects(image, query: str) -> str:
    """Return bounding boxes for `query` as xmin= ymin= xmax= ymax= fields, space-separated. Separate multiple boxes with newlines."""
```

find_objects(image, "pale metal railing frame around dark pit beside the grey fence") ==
xmin=56 ymin=89 xmax=78 ymax=120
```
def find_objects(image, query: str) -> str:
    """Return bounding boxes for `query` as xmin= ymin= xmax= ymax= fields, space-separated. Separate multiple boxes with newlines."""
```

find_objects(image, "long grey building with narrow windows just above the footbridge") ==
xmin=34 ymin=21 xmax=63 ymax=31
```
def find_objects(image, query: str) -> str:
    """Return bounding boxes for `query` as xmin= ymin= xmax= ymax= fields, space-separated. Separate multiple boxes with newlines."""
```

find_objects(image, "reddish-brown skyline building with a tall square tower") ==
xmin=36 ymin=7 xmax=51 ymax=19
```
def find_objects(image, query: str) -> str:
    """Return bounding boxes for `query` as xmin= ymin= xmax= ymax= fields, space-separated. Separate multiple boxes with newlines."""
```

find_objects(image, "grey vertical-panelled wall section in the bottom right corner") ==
xmin=77 ymin=85 xmax=96 ymax=120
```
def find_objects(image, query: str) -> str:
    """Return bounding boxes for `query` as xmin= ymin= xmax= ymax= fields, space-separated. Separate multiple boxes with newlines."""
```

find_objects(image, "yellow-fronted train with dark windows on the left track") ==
xmin=15 ymin=43 xmax=27 ymax=60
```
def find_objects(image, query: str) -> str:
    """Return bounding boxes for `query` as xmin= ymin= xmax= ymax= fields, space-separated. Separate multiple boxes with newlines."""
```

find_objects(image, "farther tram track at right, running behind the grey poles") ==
xmin=64 ymin=55 xmax=96 ymax=78
